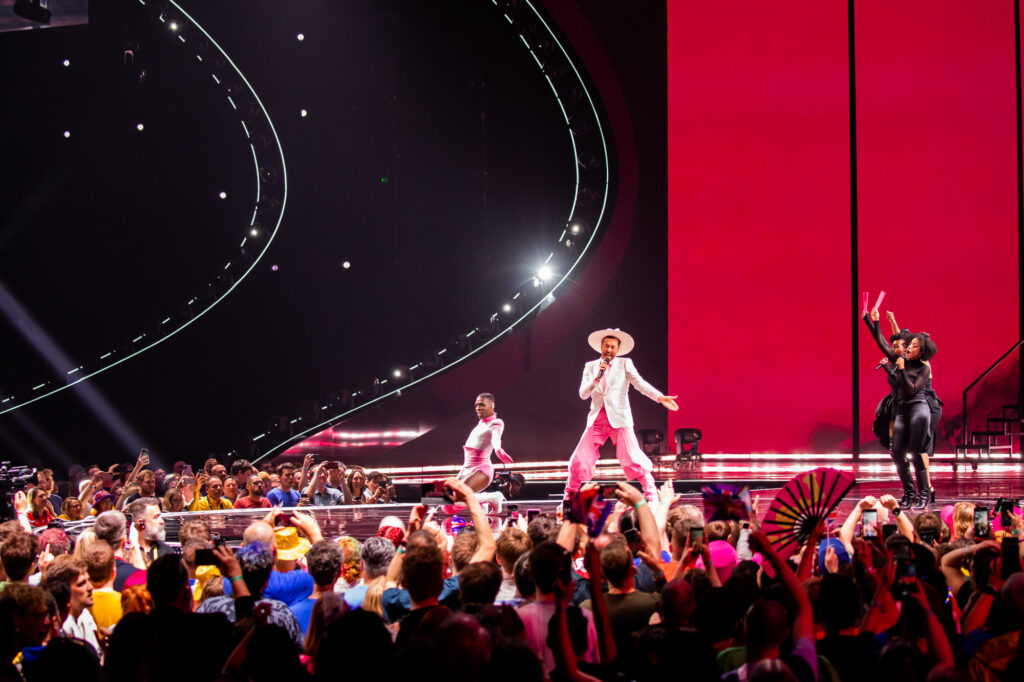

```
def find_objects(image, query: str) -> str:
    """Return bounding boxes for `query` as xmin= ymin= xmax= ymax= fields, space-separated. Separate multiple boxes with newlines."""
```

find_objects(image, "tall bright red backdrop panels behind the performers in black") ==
xmin=668 ymin=0 xmax=1020 ymax=453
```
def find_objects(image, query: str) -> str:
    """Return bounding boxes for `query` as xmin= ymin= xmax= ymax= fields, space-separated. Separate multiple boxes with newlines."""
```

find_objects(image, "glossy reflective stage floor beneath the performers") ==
xmin=164 ymin=461 xmax=1024 ymax=544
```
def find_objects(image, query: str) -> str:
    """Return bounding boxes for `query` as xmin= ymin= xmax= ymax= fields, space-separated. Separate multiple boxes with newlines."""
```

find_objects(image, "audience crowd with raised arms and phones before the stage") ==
xmin=0 ymin=453 xmax=1024 ymax=682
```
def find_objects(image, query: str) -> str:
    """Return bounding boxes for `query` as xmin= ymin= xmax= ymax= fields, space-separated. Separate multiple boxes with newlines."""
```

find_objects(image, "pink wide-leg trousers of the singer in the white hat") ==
xmin=565 ymin=409 xmax=657 ymax=500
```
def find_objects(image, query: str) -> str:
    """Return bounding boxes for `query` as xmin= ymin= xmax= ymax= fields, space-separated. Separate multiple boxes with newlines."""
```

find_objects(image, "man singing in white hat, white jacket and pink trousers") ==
xmin=565 ymin=329 xmax=679 ymax=501
